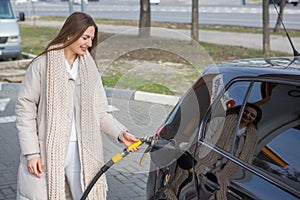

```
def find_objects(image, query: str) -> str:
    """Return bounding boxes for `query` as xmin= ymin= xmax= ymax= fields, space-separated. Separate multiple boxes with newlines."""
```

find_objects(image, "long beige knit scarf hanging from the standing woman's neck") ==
xmin=46 ymin=47 xmax=107 ymax=200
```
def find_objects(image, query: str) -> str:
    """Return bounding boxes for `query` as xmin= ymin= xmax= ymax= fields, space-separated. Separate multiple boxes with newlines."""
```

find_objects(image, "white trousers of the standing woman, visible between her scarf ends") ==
xmin=65 ymin=141 xmax=83 ymax=200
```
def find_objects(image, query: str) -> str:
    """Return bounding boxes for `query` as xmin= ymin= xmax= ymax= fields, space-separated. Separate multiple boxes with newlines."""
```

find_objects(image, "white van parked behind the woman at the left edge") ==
xmin=0 ymin=0 xmax=25 ymax=60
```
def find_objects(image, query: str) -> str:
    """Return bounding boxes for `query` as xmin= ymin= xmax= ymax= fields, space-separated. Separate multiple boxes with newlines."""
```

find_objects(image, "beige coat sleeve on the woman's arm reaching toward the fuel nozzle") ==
xmin=99 ymin=80 xmax=128 ymax=141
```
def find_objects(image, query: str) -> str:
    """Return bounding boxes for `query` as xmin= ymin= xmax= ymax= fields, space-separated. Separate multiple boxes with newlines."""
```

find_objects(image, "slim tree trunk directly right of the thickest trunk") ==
xmin=191 ymin=0 xmax=199 ymax=44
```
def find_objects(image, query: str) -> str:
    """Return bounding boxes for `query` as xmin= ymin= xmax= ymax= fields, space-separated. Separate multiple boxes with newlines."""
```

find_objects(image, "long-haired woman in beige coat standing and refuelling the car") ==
xmin=16 ymin=12 xmax=138 ymax=200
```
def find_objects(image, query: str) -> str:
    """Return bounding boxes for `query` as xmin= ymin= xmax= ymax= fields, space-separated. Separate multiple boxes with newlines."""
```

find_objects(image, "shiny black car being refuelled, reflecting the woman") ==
xmin=147 ymin=58 xmax=300 ymax=200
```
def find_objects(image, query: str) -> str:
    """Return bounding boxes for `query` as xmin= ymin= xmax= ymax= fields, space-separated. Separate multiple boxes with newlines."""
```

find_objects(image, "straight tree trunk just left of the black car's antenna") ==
xmin=262 ymin=0 xmax=270 ymax=57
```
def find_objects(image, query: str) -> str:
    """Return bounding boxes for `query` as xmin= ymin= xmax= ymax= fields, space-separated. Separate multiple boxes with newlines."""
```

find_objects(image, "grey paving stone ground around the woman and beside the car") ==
xmin=0 ymin=83 xmax=172 ymax=200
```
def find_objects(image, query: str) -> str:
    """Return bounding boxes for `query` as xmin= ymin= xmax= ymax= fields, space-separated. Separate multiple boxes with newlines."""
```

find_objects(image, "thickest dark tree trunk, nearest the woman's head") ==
xmin=139 ymin=0 xmax=151 ymax=37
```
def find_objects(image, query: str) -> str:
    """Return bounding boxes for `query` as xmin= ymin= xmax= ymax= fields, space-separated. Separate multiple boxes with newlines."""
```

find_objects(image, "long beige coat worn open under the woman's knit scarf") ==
xmin=16 ymin=55 xmax=126 ymax=200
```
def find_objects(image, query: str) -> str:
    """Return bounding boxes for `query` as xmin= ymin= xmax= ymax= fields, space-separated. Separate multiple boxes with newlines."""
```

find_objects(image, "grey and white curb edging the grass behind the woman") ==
xmin=0 ymin=82 xmax=180 ymax=106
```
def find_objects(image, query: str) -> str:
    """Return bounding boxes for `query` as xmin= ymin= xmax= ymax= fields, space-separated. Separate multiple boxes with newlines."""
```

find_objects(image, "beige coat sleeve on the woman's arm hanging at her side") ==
xmin=15 ymin=58 xmax=41 ymax=156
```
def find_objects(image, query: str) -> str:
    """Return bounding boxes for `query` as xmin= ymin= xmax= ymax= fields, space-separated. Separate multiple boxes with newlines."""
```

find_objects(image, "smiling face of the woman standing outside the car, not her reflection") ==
xmin=69 ymin=26 xmax=95 ymax=56
